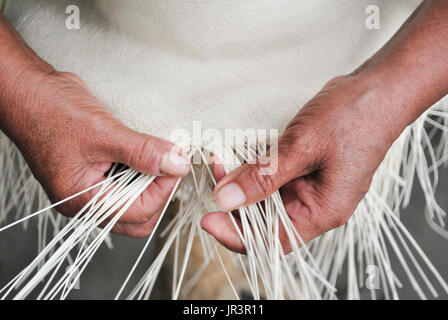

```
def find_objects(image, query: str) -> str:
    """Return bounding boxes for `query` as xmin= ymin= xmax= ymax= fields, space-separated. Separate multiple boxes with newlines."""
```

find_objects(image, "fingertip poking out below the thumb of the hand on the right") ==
xmin=201 ymin=212 xmax=246 ymax=253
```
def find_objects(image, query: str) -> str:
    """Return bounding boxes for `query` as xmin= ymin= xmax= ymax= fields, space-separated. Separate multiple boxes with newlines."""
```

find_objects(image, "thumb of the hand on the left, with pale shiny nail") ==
xmin=103 ymin=123 xmax=190 ymax=177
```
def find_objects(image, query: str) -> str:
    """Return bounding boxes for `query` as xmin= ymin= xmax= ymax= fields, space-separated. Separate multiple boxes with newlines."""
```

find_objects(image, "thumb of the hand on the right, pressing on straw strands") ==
xmin=214 ymin=135 xmax=314 ymax=211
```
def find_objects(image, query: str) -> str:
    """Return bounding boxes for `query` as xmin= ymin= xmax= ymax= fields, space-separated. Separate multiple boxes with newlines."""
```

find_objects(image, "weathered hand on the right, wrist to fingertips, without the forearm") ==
xmin=202 ymin=75 xmax=406 ymax=252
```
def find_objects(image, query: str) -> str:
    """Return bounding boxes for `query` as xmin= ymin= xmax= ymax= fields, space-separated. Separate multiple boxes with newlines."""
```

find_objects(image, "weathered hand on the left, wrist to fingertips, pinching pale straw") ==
xmin=2 ymin=72 xmax=190 ymax=237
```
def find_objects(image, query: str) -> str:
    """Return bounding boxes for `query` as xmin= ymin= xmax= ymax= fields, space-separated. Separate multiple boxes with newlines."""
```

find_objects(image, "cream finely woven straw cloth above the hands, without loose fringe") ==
xmin=6 ymin=0 xmax=416 ymax=138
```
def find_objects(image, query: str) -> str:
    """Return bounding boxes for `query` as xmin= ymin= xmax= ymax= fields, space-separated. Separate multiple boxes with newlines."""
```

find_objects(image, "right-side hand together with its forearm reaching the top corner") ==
xmin=202 ymin=0 xmax=448 ymax=252
